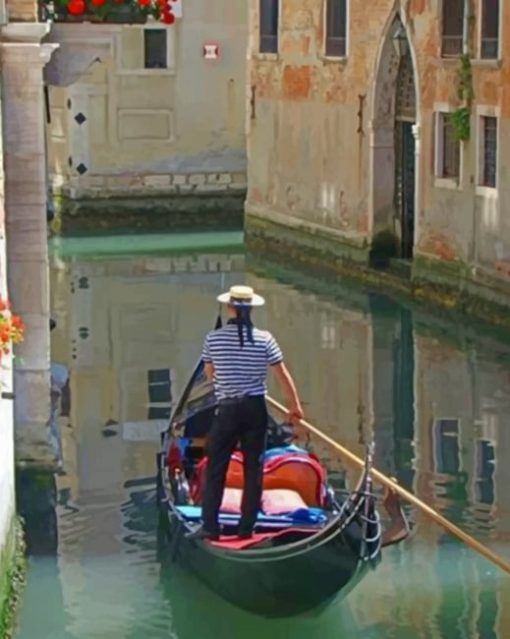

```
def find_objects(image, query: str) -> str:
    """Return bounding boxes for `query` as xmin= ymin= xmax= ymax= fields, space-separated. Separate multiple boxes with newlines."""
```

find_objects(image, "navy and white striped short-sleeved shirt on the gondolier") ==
xmin=202 ymin=324 xmax=283 ymax=400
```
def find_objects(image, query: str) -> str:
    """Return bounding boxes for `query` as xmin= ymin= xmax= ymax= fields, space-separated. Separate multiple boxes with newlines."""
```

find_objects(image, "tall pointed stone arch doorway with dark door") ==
xmin=371 ymin=14 xmax=420 ymax=259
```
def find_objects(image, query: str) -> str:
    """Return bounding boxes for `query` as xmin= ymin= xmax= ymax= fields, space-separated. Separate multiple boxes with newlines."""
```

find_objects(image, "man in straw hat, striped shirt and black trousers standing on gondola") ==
xmin=192 ymin=286 xmax=303 ymax=539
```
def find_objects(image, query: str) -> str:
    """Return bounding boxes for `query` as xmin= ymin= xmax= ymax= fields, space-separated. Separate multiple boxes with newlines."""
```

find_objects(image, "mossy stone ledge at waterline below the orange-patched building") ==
xmin=245 ymin=206 xmax=510 ymax=330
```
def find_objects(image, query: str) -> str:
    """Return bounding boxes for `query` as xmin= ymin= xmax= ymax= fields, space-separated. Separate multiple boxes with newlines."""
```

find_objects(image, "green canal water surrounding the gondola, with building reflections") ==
xmin=11 ymin=233 xmax=510 ymax=639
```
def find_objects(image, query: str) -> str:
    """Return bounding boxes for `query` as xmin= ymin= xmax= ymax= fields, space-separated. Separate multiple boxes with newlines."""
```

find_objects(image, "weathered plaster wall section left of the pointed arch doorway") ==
xmin=248 ymin=0 xmax=378 ymax=237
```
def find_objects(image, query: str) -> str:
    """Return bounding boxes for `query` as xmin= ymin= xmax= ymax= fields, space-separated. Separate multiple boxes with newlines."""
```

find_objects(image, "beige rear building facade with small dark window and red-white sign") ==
xmin=46 ymin=0 xmax=247 ymax=201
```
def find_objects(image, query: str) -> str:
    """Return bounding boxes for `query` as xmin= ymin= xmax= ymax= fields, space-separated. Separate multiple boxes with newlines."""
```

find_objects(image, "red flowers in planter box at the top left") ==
xmin=46 ymin=0 xmax=177 ymax=24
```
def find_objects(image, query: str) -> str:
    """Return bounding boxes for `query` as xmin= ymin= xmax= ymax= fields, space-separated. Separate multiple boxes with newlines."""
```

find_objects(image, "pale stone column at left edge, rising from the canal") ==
xmin=0 ymin=23 xmax=58 ymax=466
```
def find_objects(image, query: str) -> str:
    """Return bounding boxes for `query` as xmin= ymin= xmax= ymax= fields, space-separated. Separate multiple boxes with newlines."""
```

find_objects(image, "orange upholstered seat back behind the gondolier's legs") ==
xmin=225 ymin=459 xmax=321 ymax=507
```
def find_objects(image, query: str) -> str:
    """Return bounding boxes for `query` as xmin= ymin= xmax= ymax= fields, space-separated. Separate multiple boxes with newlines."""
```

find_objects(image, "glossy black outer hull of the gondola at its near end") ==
xmin=157 ymin=508 xmax=373 ymax=617
